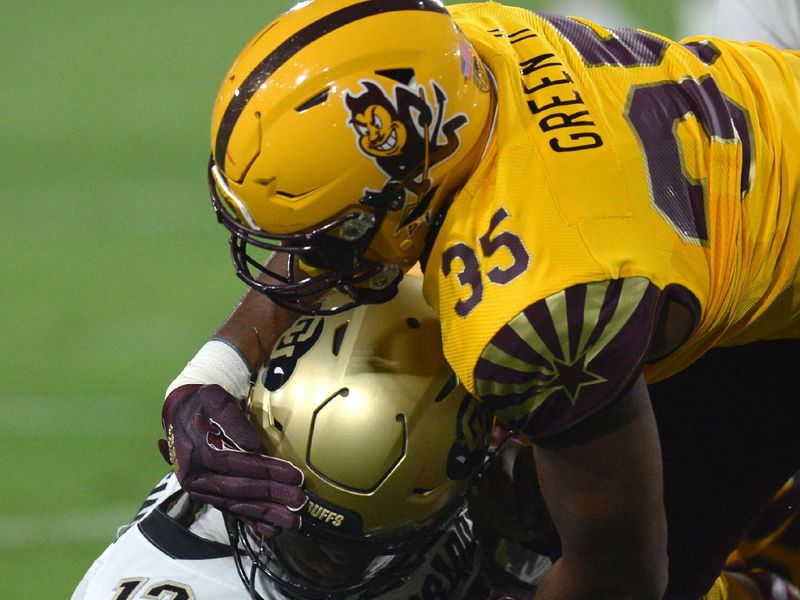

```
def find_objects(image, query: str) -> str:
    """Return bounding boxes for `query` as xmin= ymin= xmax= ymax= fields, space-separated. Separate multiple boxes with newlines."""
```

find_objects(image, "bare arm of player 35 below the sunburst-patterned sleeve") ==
xmin=535 ymin=376 xmax=667 ymax=600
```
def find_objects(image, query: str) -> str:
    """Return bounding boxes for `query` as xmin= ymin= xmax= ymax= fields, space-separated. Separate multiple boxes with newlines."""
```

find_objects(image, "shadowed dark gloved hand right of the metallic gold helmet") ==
xmin=467 ymin=435 xmax=555 ymax=542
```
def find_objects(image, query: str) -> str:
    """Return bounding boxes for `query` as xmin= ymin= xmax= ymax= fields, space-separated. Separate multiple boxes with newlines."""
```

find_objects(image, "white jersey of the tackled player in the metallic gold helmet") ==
xmin=72 ymin=475 xmax=488 ymax=600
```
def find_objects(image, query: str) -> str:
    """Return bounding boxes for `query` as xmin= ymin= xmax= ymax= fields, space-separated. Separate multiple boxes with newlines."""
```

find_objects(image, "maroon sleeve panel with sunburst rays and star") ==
xmin=475 ymin=277 xmax=663 ymax=439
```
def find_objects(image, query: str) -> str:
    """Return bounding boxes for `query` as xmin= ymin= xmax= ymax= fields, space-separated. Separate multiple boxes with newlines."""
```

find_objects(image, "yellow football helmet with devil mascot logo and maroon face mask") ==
xmin=209 ymin=0 xmax=494 ymax=314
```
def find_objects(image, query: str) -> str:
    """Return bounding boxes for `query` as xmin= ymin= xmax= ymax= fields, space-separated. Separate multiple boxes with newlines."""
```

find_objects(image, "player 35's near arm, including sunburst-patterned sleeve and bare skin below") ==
xmin=474 ymin=277 xmax=696 ymax=599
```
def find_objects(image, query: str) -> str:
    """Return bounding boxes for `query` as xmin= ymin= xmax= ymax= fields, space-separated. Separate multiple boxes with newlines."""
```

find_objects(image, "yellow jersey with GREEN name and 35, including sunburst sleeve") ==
xmin=425 ymin=2 xmax=800 ymax=437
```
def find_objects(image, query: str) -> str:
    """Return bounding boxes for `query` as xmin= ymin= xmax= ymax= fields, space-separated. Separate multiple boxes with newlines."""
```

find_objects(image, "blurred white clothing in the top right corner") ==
xmin=713 ymin=0 xmax=800 ymax=50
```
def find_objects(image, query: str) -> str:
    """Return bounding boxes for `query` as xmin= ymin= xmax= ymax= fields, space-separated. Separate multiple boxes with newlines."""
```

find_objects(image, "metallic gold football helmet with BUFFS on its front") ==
xmin=231 ymin=276 xmax=491 ymax=598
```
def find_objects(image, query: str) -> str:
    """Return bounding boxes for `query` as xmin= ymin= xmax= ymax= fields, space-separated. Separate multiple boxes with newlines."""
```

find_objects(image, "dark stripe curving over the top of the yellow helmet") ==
xmin=214 ymin=0 xmax=447 ymax=170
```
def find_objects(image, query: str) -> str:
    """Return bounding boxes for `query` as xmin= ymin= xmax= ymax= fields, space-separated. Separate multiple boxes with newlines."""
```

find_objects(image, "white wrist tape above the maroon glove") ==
xmin=165 ymin=340 xmax=250 ymax=399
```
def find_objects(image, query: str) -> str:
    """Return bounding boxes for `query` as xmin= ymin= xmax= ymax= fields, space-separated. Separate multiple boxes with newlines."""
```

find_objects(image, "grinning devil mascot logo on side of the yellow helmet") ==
xmin=345 ymin=80 xmax=467 ymax=235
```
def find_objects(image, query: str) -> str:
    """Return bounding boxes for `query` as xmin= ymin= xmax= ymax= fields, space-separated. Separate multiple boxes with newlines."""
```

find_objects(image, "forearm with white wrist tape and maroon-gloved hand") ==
xmin=159 ymin=253 xmax=306 ymax=536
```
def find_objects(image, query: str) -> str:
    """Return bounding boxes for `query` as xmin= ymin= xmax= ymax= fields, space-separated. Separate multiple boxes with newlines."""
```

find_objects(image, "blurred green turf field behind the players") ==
xmin=0 ymin=0 xmax=692 ymax=599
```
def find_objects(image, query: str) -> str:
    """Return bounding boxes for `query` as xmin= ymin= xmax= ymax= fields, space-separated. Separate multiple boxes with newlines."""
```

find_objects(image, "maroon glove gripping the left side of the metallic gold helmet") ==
xmin=158 ymin=385 xmax=306 ymax=537
